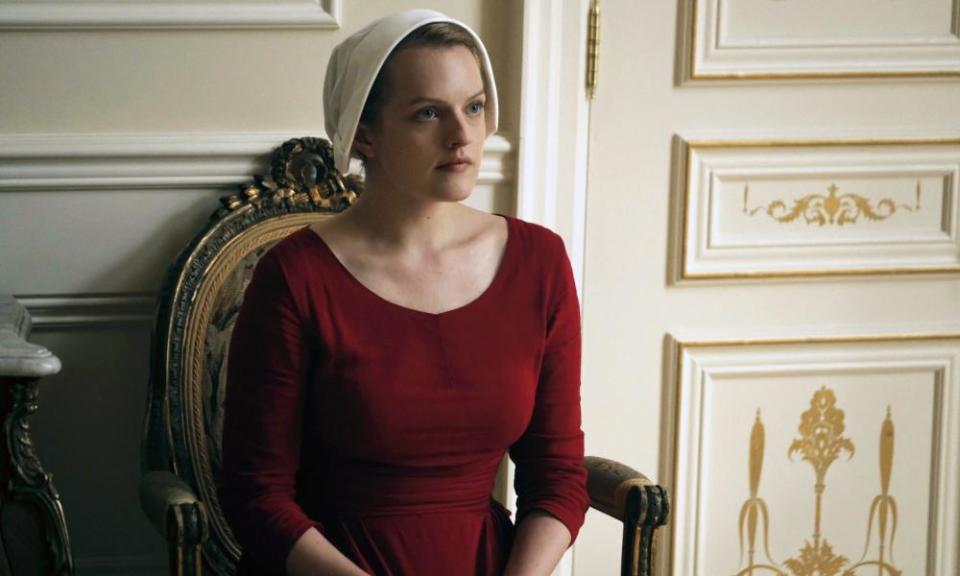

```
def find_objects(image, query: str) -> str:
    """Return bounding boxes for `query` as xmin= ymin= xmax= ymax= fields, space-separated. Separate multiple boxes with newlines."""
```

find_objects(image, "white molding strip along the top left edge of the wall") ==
xmin=0 ymin=0 xmax=342 ymax=30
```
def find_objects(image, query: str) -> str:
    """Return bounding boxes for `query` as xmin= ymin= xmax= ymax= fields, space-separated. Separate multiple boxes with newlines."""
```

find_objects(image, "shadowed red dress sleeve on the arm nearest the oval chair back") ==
xmin=218 ymin=252 xmax=320 ymax=574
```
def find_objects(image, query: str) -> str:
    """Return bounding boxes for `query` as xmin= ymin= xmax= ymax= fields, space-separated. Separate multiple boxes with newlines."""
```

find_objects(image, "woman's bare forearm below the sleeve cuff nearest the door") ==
xmin=503 ymin=510 xmax=570 ymax=576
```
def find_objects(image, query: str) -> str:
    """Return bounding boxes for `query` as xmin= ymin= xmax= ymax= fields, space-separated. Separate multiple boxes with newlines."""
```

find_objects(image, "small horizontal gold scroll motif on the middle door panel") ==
xmin=743 ymin=180 xmax=920 ymax=226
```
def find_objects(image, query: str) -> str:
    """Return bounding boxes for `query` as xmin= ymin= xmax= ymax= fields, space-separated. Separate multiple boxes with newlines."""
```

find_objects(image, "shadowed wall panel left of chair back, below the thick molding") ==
xmin=0 ymin=189 xmax=229 ymax=295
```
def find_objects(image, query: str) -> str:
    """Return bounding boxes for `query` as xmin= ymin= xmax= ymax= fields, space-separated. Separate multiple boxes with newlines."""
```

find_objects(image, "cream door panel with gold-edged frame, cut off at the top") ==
xmin=684 ymin=0 xmax=960 ymax=79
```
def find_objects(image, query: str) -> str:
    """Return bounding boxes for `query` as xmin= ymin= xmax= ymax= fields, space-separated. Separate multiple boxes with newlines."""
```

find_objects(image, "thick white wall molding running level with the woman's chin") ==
xmin=0 ymin=132 xmax=514 ymax=193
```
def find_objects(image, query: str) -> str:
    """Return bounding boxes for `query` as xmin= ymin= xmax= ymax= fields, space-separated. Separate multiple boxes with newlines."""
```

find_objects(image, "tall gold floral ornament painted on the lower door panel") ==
xmin=736 ymin=386 xmax=901 ymax=576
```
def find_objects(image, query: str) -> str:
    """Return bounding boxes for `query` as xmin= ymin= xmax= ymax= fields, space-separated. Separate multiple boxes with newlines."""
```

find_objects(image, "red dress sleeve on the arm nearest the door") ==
xmin=510 ymin=233 xmax=590 ymax=544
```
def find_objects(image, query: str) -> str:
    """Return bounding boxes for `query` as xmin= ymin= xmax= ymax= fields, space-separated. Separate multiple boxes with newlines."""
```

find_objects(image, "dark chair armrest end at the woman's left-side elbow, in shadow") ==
xmin=140 ymin=470 xmax=208 ymax=545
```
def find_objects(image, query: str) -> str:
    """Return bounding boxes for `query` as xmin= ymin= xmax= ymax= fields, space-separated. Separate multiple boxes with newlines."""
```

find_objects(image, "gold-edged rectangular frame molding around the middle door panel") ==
xmin=675 ymin=135 xmax=960 ymax=282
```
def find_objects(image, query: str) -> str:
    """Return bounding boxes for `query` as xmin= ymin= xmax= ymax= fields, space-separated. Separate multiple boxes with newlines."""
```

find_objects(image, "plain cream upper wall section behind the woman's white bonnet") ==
xmin=0 ymin=0 xmax=522 ymax=134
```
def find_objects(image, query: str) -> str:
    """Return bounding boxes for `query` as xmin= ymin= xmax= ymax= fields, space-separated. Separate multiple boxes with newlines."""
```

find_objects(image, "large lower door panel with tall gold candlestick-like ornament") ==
xmin=667 ymin=337 xmax=960 ymax=576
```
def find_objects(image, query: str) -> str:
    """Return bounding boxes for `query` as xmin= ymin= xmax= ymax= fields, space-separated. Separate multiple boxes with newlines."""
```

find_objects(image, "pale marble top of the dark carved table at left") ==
xmin=0 ymin=294 xmax=60 ymax=378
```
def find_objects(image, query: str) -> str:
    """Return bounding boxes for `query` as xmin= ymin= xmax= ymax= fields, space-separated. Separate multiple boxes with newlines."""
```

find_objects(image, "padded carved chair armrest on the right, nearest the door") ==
xmin=583 ymin=456 xmax=669 ymax=527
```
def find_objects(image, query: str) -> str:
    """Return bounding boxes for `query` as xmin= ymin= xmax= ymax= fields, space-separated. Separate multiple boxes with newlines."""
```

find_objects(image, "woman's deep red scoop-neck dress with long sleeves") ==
xmin=219 ymin=217 xmax=589 ymax=576
